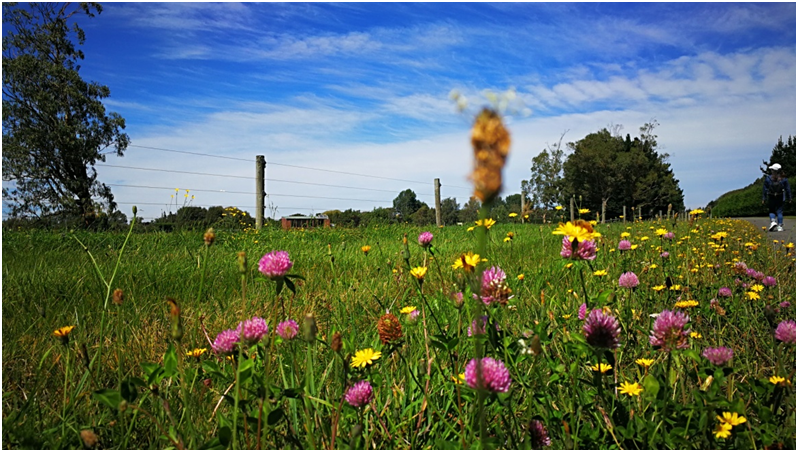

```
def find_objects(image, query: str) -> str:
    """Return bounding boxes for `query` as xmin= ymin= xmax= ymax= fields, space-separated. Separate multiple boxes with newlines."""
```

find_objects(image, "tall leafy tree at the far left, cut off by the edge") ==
xmin=2 ymin=2 xmax=129 ymax=224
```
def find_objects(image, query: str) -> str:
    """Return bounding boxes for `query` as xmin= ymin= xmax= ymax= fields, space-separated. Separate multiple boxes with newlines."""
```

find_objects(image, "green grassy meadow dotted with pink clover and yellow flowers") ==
xmin=2 ymin=217 xmax=796 ymax=449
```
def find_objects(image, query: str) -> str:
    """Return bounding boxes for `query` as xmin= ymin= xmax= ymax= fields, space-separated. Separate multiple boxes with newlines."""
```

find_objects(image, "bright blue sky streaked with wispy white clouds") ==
xmin=59 ymin=3 xmax=796 ymax=218
